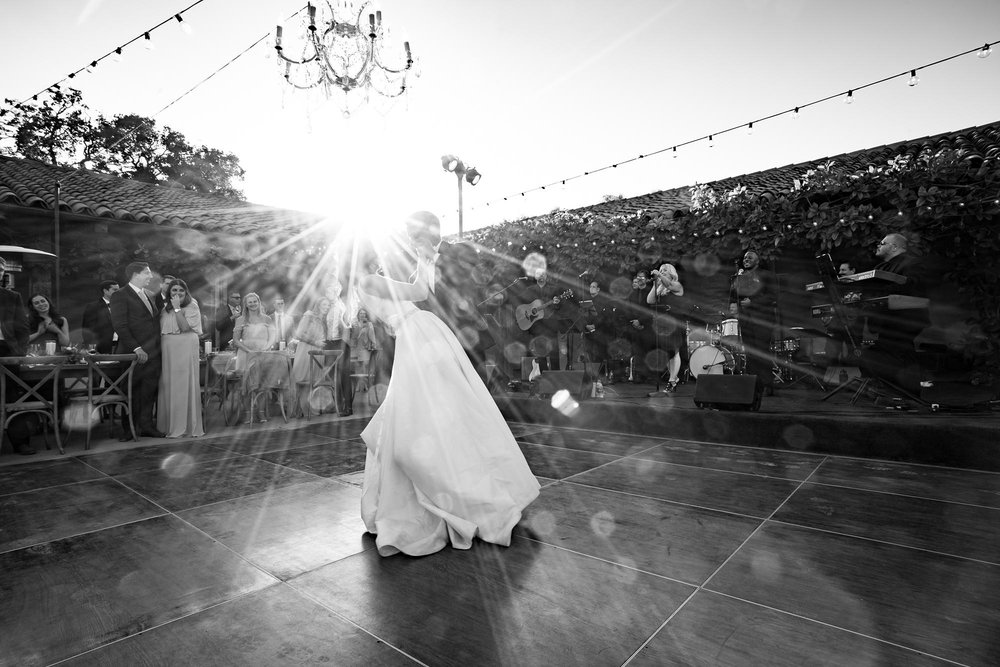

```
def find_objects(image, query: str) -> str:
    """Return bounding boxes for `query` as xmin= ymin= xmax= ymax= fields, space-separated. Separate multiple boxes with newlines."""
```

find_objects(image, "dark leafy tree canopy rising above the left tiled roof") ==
xmin=0 ymin=88 xmax=245 ymax=200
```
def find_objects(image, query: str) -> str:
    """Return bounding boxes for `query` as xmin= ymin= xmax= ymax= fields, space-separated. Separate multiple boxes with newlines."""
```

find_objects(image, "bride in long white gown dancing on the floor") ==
xmin=359 ymin=217 xmax=539 ymax=556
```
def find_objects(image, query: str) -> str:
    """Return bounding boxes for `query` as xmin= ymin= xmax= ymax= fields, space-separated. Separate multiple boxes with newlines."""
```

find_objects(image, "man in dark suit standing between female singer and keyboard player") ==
xmin=729 ymin=249 xmax=778 ymax=396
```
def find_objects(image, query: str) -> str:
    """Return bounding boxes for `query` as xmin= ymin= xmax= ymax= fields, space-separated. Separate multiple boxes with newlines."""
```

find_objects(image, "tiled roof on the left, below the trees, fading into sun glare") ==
xmin=0 ymin=156 xmax=322 ymax=235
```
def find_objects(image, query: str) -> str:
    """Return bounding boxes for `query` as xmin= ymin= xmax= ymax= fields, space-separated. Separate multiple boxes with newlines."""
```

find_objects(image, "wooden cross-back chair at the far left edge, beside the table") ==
xmin=0 ymin=356 xmax=69 ymax=454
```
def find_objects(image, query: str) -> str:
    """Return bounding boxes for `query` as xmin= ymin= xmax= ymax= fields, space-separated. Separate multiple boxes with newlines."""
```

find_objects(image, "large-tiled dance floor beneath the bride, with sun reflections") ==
xmin=0 ymin=419 xmax=1000 ymax=667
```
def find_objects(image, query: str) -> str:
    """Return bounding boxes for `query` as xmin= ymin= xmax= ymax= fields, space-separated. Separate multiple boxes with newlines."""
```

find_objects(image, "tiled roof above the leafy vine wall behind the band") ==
xmin=556 ymin=121 xmax=1000 ymax=222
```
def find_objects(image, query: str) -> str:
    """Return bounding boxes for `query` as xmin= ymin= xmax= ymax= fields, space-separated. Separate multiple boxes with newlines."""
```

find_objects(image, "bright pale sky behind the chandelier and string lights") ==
xmin=0 ymin=0 xmax=1000 ymax=240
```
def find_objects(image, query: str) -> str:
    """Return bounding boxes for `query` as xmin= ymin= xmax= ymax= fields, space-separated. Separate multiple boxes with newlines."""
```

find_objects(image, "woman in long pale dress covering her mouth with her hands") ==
xmin=156 ymin=278 xmax=205 ymax=438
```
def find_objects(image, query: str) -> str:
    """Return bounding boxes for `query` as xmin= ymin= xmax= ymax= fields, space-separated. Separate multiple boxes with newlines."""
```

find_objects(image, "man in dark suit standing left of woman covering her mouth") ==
xmin=111 ymin=262 xmax=164 ymax=440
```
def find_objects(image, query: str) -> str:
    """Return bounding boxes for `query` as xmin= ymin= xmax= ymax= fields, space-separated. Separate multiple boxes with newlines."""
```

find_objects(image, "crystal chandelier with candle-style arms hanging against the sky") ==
xmin=274 ymin=0 xmax=414 ymax=117
